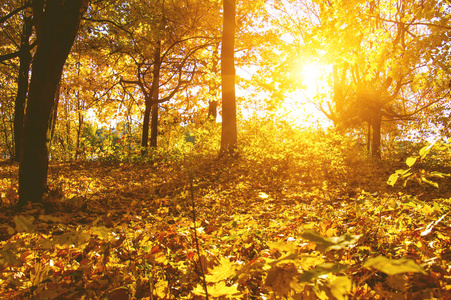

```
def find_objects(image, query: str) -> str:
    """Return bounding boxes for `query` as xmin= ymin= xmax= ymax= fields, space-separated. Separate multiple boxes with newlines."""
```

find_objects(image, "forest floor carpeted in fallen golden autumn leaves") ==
xmin=0 ymin=158 xmax=451 ymax=299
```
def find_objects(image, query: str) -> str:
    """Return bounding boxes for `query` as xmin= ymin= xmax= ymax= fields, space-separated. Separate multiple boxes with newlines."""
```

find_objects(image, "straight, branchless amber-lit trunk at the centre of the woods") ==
xmin=220 ymin=0 xmax=237 ymax=155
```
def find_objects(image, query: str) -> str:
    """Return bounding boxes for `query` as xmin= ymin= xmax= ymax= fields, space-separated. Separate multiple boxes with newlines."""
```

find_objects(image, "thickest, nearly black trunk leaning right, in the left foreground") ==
xmin=19 ymin=0 xmax=88 ymax=206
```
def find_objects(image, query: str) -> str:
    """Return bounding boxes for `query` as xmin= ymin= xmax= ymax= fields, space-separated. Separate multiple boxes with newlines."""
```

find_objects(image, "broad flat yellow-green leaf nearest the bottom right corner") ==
xmin=363 ymin=255 xmax=426 ymax=275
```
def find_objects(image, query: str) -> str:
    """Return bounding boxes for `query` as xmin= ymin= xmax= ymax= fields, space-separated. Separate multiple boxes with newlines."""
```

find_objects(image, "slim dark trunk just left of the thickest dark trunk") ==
xmin=14 ymin=4 xmax=33 ymax=161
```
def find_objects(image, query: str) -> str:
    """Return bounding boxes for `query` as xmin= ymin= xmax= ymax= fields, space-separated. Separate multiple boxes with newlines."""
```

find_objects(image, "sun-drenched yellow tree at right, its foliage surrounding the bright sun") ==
xmin=264 ymin=0 xmax=449 ymax=158
